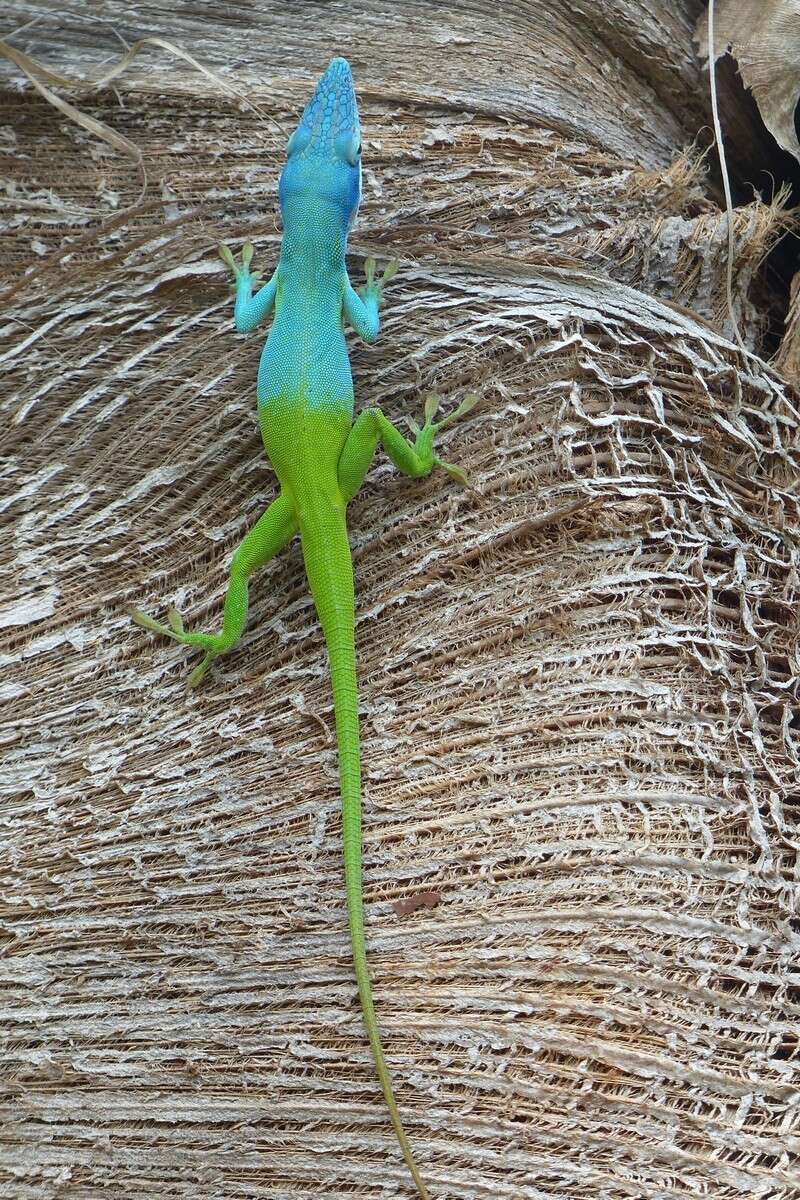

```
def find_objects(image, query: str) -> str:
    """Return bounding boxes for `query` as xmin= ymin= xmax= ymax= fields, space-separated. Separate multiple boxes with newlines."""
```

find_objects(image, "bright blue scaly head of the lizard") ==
xmin=278 ymin=59 xmax=361 ymax=227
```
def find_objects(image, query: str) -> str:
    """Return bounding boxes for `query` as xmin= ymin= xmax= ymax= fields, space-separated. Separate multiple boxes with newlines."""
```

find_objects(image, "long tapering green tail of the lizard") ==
xmin=300 ymin=509 xmax=431 ymax=1200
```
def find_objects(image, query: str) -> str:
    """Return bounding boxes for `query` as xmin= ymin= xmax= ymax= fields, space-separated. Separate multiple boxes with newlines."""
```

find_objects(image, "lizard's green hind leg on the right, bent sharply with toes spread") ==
xmin=338 ymin=392 xmax=477 ymax=503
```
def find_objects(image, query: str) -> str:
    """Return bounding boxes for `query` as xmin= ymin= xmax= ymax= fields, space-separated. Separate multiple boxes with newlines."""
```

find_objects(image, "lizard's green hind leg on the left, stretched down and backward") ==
xmin=130 ymin=496 xmax=297 ymax=688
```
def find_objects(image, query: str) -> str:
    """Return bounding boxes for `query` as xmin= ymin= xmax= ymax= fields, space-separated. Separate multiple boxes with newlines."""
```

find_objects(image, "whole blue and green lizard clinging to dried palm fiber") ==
xmin=131 ymin=58 xmax=477 ymax=1200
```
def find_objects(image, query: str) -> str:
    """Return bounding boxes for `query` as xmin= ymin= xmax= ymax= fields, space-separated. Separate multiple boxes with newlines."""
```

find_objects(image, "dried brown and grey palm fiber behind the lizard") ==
xmin=0 ymin=2 xmax=800 ymax=1200
